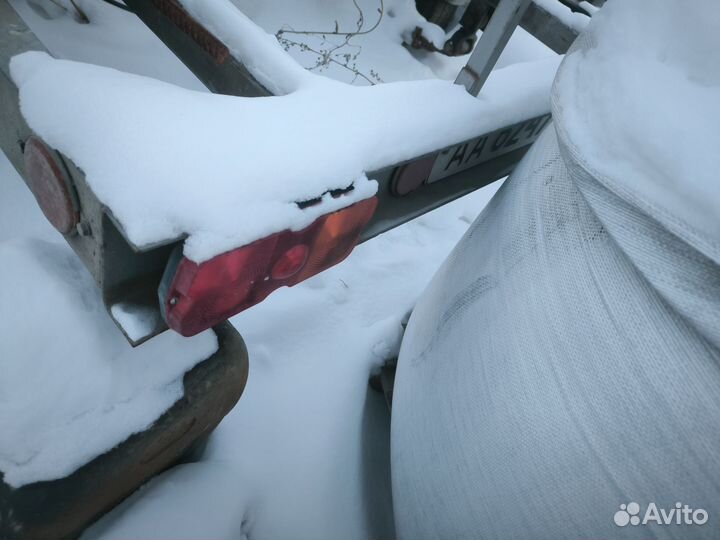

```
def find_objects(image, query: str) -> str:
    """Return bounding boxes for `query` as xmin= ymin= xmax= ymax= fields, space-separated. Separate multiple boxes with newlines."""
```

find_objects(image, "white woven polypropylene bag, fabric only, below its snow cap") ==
xmin=391 ymin=16 xmax=720 ymax=540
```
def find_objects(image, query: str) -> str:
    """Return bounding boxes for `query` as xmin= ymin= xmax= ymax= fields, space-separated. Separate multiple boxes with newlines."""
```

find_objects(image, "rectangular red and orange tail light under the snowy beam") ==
xmin=159 ymin=197 xmax=377 ymax=336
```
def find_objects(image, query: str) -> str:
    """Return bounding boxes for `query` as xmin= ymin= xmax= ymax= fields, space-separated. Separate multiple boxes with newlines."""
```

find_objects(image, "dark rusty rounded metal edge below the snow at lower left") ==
xmin=0 ymin=323 xmax=248 ymax=540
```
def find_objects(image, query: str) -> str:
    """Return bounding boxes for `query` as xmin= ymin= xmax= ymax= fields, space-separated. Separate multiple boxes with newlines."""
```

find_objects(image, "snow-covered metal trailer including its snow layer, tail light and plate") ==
xmin=0 ymin=0 xmax=576 ymax=345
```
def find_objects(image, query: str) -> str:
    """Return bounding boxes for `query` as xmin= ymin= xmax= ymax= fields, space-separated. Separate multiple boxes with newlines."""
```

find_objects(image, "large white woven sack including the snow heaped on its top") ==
xmin=392 ymin=0 xmax=720 ymax=540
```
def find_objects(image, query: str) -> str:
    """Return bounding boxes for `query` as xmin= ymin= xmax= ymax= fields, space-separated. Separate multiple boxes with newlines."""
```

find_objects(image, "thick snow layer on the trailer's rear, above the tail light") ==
xmin=11 ymin=52 xmax=559 ymax=262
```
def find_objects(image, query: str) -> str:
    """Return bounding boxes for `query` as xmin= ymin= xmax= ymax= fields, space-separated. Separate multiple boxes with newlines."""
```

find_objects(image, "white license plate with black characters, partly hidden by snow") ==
xmin=427 ymin=114 xmax=550 ymax=184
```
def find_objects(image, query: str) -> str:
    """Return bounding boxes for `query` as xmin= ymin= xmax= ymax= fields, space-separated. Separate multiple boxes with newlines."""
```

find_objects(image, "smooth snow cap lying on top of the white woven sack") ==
xmin=553 ymin=0 xmax=720 ymax=257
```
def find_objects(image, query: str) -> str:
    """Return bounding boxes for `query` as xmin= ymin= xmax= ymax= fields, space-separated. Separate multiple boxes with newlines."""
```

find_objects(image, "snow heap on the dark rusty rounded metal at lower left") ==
xmin=0 ymin=238 xmax=217 ymax=487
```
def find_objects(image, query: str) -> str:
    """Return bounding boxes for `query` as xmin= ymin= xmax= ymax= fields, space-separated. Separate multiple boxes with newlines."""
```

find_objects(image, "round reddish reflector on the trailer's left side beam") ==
xmin=23 ymin=137 xmax=80 ymax=234
